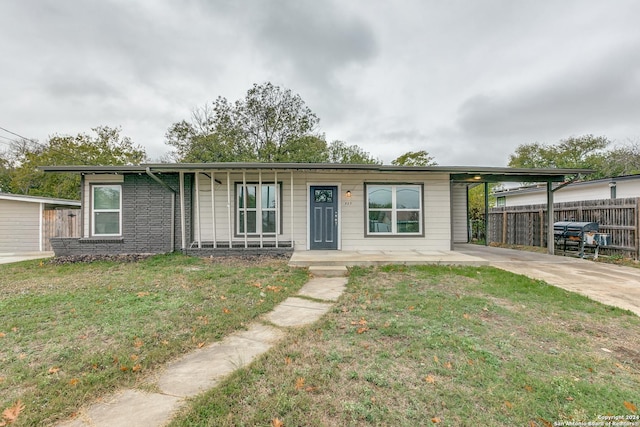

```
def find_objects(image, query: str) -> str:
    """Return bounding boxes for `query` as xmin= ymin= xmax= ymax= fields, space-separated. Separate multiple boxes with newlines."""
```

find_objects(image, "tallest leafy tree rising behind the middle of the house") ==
xmin=166 ymin=83 xmax=327 ymax=162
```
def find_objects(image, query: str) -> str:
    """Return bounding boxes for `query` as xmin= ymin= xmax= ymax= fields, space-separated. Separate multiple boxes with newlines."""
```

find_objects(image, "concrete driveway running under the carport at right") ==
xmin=455 ymin=244 xmax=640 ymax=316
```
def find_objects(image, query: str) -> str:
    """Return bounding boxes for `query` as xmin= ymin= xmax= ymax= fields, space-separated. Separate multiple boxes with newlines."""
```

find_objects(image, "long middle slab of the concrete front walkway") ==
xmin=158 ymin=324 xmax=284 ymax=397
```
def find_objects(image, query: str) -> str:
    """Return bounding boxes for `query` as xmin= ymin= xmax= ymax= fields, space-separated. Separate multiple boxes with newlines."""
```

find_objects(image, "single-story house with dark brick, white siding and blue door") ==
xmin=40 ymin=163 xmax=589 ymax=256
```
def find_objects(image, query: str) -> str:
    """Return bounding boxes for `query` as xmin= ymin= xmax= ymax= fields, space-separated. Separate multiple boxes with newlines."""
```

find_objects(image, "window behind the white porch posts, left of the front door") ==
xmin=236 ymin=183 xmax=281 ymax=234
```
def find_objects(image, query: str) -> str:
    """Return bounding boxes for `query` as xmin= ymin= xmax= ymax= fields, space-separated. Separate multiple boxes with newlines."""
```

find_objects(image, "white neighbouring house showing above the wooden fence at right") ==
xmin=494 ymin=175 xmax=640 ymax=207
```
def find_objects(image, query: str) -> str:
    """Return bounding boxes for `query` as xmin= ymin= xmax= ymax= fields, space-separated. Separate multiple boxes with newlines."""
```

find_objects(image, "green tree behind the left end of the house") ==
xmin=8 ymin=126 xmax=146 ymax=199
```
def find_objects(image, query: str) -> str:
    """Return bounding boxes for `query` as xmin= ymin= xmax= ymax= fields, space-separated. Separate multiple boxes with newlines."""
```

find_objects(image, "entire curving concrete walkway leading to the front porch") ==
xmin=58 ymin=267 xmax=347 ymax=427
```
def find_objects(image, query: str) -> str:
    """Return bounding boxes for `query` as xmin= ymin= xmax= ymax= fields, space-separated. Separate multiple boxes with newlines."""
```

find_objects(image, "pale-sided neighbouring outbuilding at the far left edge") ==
xmin=0 ymin=193 xmax=80 ymax=253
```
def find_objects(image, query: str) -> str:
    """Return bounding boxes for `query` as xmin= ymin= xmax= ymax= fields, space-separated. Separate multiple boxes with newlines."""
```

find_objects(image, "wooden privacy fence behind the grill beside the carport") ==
xmin=488 ymin=198 xmax=640 ymax=260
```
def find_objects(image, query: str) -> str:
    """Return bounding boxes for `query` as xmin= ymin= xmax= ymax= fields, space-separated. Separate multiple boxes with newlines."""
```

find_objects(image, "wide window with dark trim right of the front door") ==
xmin=367 ymin=184 xmax=422 ymax=235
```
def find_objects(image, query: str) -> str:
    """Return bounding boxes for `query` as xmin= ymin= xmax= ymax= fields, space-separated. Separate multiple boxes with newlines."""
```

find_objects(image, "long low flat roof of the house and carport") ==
xmin=38 ymin=162 xmax=593 ymax=183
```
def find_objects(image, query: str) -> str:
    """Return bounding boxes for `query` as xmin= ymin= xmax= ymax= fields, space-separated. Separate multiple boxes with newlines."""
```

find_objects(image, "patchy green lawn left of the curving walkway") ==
xmin=0 ymin=255 xmax=307 ymax=426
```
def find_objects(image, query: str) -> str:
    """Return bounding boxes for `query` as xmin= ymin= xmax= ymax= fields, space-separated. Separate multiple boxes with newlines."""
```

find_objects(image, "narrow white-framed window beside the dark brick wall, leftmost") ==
xmin=91 ymin=184 xmax=122 ymax=236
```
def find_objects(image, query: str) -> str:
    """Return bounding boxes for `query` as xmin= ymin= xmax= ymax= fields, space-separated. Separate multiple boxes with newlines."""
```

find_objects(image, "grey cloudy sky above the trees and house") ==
xmin=0 ymin=0 xmax=640 ymax=166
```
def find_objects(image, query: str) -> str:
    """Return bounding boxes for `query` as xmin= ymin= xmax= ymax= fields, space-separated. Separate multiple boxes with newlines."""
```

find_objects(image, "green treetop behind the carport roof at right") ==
xmin=509 ymin=135 xmax=611 ymax=174
